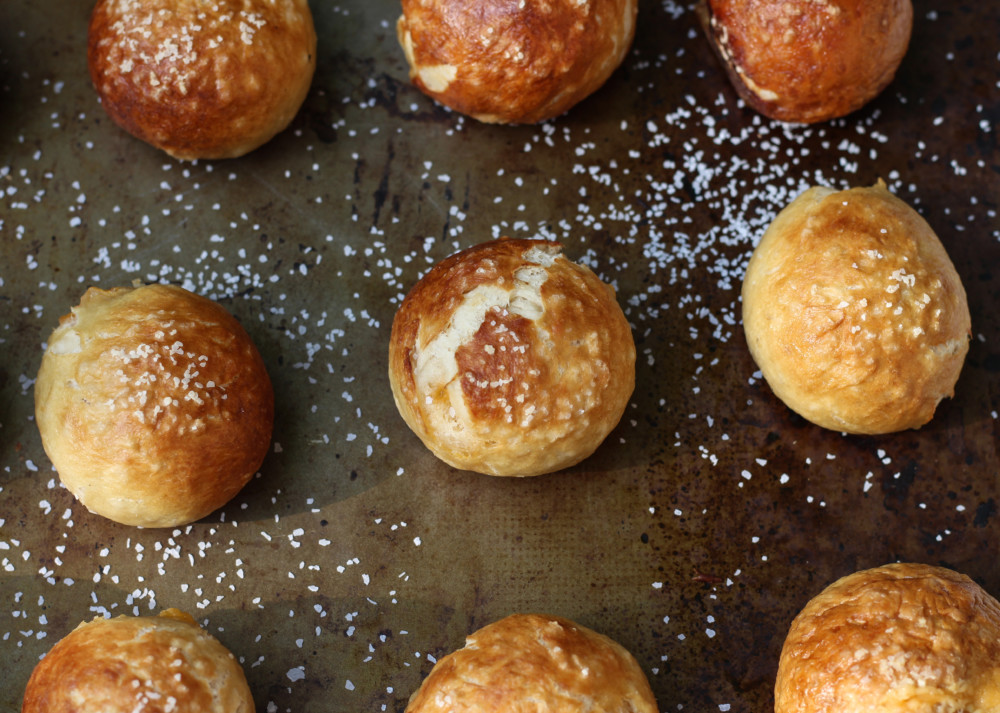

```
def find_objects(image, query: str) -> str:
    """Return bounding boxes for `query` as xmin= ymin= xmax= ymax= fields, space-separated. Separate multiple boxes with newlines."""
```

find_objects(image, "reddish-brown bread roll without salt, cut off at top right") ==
xmin=698 ymin=0 xmax=913 ymax=124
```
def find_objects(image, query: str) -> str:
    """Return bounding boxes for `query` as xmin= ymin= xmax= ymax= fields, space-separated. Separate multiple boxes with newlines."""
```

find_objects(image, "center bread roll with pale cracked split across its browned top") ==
xmin=389 ymin=239 xmax=635 ymax=476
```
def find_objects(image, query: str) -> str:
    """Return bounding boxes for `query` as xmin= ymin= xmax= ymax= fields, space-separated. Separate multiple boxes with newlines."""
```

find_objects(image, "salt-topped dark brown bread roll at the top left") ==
xmin=87 ymin=0 xmax=316 ymax=160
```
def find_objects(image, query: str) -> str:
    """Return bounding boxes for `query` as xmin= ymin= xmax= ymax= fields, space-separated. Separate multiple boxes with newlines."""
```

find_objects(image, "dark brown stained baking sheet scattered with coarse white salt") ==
xmin=0 ymin=0 xmax=1000 ymax=713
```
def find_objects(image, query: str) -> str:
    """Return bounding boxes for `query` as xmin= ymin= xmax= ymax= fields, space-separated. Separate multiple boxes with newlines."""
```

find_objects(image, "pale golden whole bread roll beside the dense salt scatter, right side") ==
xmin=743 ymin=181 xmax=971 ymax=434
